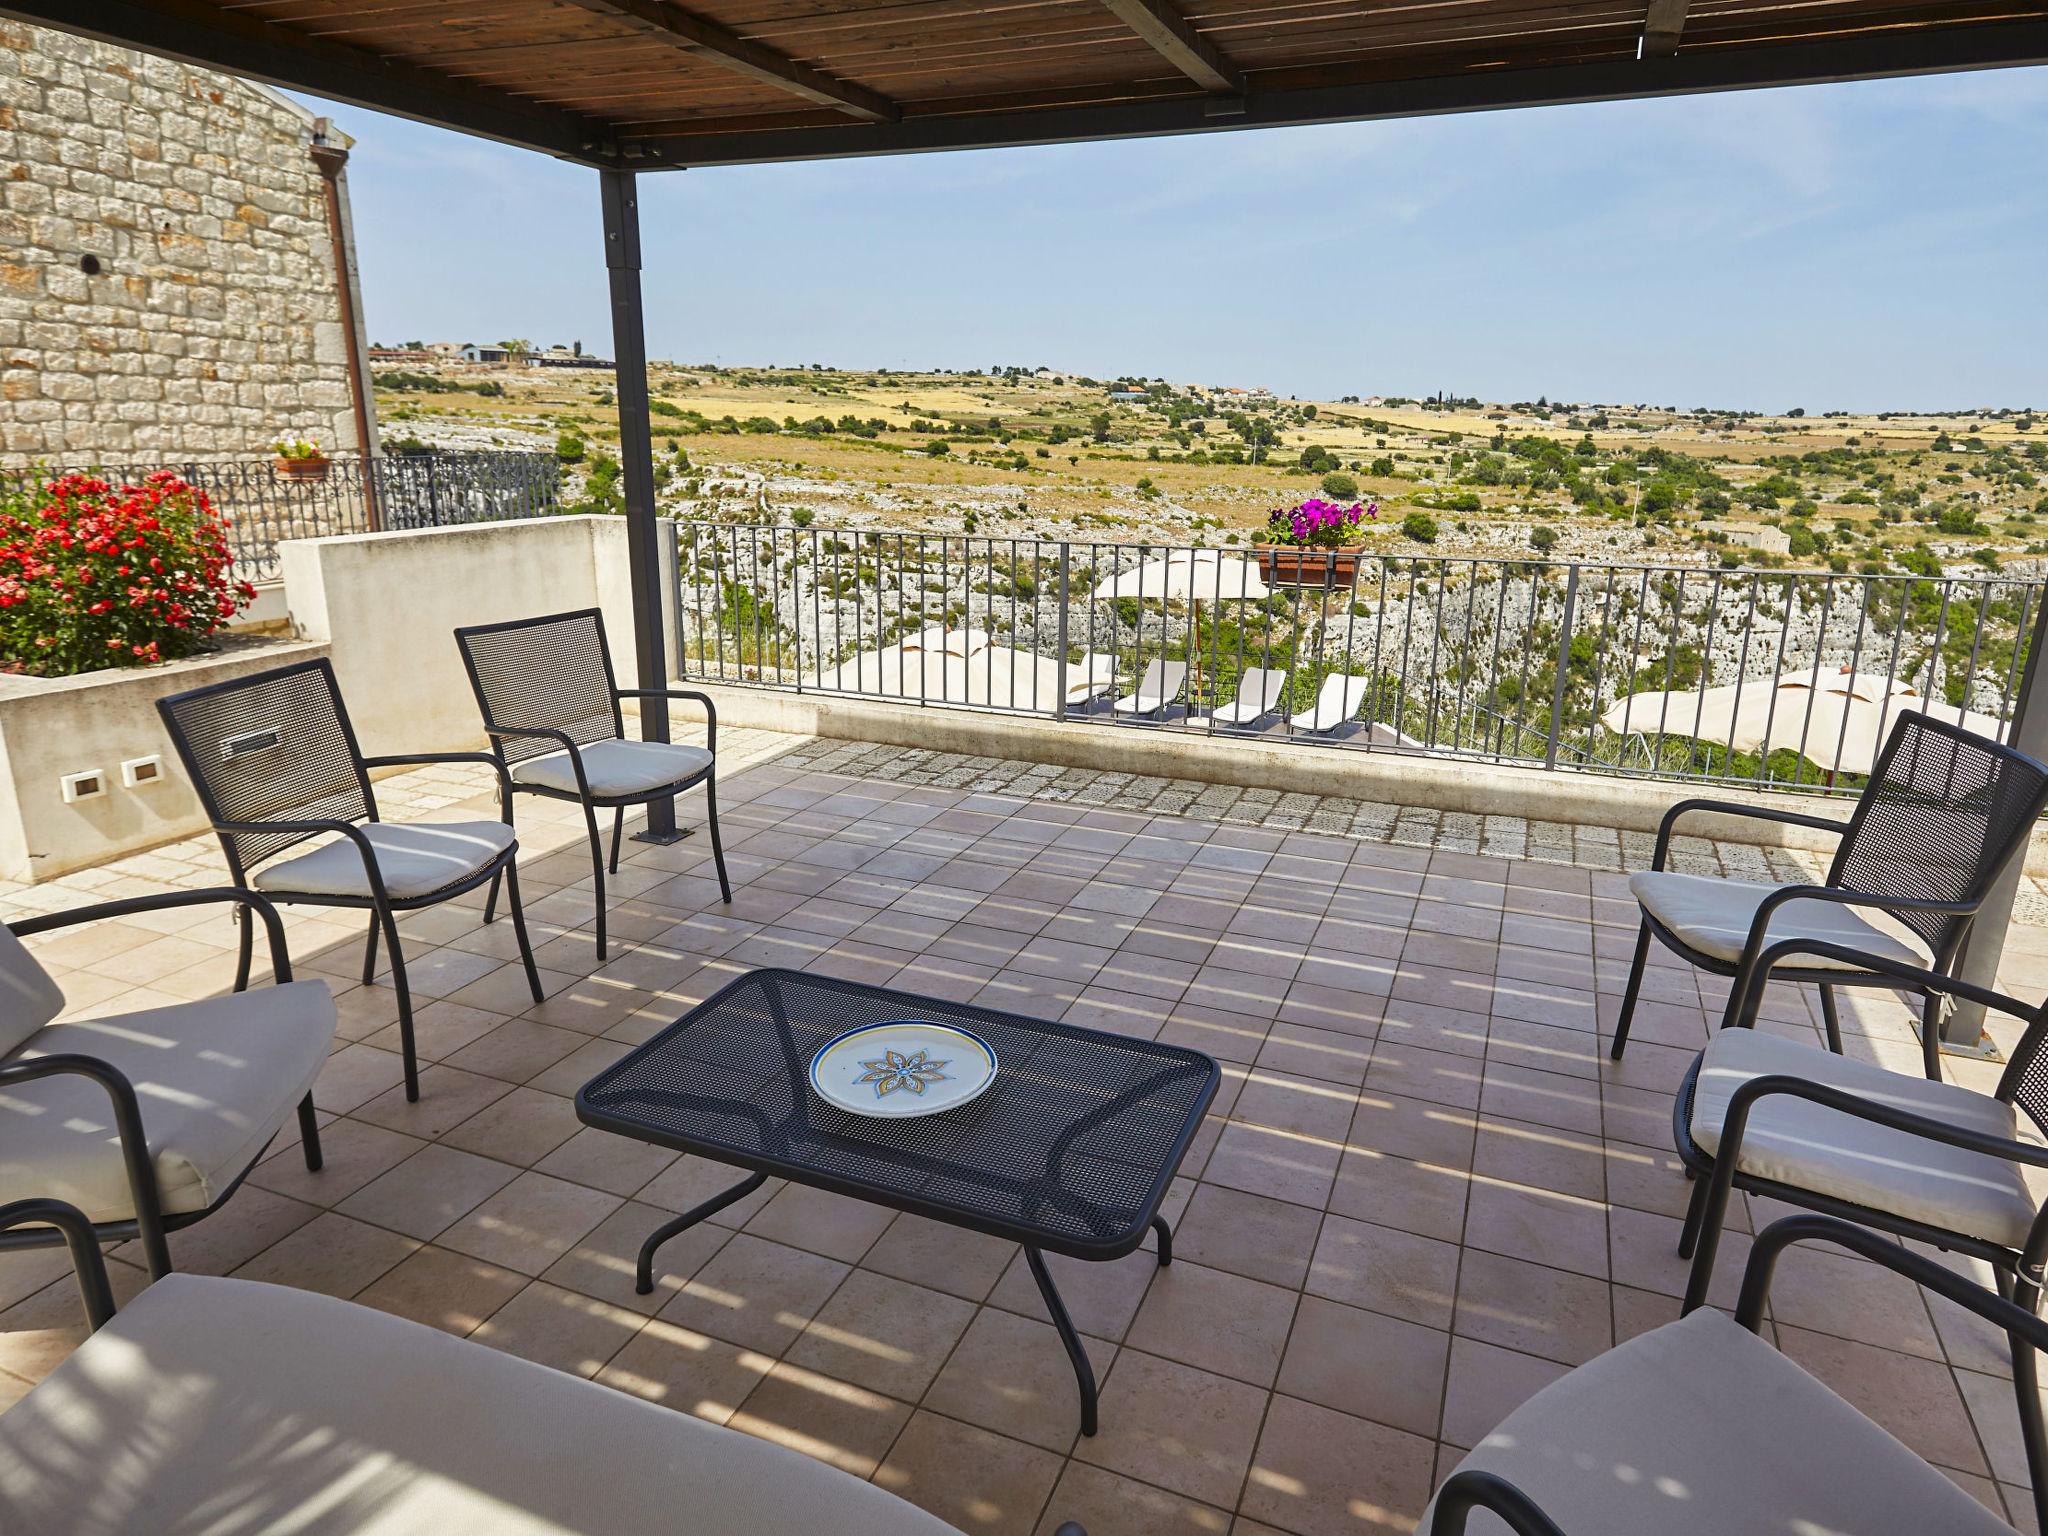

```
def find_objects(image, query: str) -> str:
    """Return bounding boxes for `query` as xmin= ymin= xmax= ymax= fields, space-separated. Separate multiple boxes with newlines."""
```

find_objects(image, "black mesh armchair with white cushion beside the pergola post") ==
xmin=455 ymin=608 xmax=733 ymax=961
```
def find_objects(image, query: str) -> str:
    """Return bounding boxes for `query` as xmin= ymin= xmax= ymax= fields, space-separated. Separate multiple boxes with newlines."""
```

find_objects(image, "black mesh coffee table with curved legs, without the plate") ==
xmin=575 ymin=971 xmax=1221 ymax=1436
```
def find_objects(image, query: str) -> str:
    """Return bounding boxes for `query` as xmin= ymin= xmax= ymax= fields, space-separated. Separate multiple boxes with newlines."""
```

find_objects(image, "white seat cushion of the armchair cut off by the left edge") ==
xmin=0 ymin=981 xmax=334 ymax=1221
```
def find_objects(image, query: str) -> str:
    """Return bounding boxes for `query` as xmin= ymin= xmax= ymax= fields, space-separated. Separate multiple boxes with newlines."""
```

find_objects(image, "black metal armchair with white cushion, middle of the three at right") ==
xmin=1671 ymin=940 xmax=2048 ymax=1493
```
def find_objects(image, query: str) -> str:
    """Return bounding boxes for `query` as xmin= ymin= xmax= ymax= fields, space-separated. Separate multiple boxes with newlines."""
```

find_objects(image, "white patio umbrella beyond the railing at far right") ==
xmin=1599 ymin=668 xmax=2005 ymax=774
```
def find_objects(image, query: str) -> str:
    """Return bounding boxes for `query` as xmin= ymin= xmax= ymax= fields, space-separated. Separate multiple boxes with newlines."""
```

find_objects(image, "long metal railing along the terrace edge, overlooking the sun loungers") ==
xmin=676 ymin=522 xmax=2042 ymax=793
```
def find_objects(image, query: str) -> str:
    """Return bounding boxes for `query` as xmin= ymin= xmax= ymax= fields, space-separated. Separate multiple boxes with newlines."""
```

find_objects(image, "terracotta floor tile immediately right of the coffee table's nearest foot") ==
xmin=1075 ymin=1350 xmax=1268 ymax=1507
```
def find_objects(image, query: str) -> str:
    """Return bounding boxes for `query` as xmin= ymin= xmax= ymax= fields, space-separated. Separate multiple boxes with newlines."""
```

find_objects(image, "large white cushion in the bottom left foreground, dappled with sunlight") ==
xmin=0 ymin=1274 xmax=958 ymax=1536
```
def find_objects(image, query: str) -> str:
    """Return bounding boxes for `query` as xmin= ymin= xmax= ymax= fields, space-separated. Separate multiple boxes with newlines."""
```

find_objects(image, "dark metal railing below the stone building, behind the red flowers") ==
xmin=0 ymin=453 xmax=561 ymax=582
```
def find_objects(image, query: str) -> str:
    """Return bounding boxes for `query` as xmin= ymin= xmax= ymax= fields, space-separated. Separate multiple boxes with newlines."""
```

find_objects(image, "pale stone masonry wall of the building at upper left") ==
xmin=0 ymin=20 xmax=362 ymax=469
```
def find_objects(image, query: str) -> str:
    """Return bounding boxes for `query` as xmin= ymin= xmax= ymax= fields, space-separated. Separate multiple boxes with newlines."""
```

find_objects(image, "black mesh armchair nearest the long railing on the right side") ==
xmin=1610 ymin=713 xmax=2048 ymax=1077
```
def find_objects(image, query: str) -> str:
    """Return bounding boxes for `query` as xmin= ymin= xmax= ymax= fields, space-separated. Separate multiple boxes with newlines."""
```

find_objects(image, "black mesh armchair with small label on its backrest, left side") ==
xmin=156 ymin=657 xmax=543 ymax=1100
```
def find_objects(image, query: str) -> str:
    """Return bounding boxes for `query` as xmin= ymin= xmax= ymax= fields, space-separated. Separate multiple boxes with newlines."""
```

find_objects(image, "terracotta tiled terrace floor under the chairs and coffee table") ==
xmin=0 ymin=731 xmax=2048 ymax=1536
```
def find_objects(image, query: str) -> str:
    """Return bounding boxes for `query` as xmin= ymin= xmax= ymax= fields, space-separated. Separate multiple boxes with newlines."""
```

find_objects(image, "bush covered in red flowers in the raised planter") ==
xmin=0 ymin=469 xmax=256 ymax=676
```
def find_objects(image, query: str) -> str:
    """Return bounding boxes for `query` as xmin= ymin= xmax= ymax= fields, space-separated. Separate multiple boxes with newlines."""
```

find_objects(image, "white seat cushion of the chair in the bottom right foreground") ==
xmin=1419 ymin=1309 xmax=2011 ymax=1536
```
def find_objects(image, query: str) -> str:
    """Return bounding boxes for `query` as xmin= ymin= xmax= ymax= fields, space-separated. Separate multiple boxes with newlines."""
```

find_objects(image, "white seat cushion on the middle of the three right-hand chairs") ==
xmin=1690 ymin=1030 xmax=2038 ymax=1247
